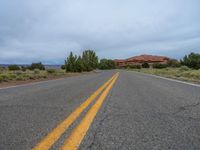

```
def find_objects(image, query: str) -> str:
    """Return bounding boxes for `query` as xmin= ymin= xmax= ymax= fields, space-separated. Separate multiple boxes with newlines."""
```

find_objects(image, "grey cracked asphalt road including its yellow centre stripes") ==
xmin=0 ymin=70 xmax=200 ymax=150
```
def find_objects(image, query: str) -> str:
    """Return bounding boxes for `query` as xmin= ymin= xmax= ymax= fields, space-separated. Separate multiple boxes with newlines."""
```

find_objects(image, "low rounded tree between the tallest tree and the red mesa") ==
xmin=99 ymin=59 xmax=116 ymax=70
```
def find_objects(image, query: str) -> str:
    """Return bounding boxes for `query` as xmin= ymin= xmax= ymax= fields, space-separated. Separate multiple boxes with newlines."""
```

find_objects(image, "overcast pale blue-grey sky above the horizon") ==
xmin=0 ymin=0 xmax=200 ymax=64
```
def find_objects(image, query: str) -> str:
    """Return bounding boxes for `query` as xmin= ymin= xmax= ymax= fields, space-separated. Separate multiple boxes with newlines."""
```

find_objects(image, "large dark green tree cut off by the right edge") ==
xmin=181 ymin=53 xmax=200 ymax=69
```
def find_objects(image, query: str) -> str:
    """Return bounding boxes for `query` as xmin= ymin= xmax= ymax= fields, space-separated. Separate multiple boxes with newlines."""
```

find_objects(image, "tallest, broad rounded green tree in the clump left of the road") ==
xmin=82 ymin=50 xmax=98 ymax=71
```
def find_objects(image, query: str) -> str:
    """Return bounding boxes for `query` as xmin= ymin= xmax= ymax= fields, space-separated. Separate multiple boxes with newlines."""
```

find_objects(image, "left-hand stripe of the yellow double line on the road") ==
xmin=33 ymin=74 xmax=116 ymax=150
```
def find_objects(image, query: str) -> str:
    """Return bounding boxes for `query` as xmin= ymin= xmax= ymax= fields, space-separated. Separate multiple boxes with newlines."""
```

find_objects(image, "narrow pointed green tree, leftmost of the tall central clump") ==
xmin=65 ymin=52 xmax=77 ymax=72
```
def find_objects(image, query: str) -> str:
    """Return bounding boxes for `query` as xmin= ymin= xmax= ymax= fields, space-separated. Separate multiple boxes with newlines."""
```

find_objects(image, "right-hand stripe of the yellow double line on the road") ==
xmin=60 ymin=74 xmax=118 ymax=150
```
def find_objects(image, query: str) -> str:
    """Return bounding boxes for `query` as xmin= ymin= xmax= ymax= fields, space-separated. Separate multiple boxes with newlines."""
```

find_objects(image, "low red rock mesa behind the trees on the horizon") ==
xmin=114 ymin=54 xmax=170 ymax=67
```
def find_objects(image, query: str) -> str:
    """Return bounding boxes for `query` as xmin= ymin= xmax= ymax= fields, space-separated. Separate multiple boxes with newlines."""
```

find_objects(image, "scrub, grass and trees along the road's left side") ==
xmin=0 ymin=50 xmax=115 ymax=85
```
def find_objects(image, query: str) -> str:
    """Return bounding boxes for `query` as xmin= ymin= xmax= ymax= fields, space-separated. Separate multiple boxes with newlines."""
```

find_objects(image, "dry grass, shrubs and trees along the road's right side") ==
xmin=126 ymin=53 xmax=200 ymax=83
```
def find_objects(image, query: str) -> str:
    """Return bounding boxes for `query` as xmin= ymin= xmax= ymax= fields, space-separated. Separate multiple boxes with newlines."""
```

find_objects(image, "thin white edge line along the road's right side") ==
xmin=128 ymin=71 xmax=200 ymax=87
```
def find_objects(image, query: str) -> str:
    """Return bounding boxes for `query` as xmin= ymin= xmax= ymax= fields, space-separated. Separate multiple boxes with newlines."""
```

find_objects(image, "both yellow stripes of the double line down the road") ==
xmin=33 ymin=73 xmax=119 ymax=150
